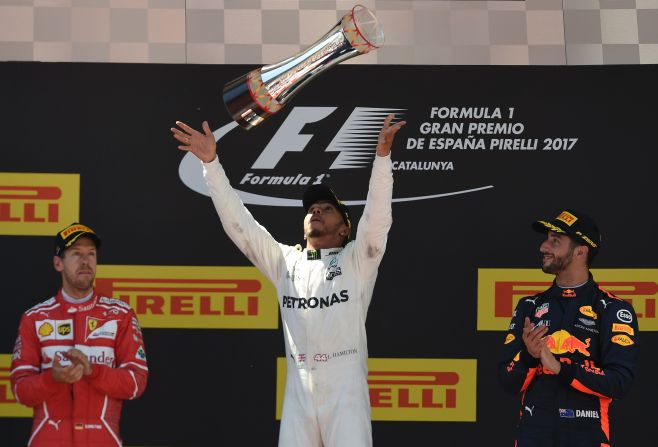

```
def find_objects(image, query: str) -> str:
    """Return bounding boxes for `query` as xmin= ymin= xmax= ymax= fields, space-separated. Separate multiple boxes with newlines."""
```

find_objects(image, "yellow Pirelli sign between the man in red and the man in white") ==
xmin=96 ymin=265 xmax=279 ymax=329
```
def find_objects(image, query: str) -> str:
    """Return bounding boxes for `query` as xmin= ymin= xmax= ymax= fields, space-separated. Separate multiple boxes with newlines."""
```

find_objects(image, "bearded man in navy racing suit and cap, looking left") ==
xmin=498 ymin=210 xmax=639 ymax=447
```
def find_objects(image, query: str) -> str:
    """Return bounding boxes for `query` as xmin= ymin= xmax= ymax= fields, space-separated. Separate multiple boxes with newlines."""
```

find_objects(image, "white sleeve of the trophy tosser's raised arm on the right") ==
xmin=354 ymin=154 xmax=393 ymax=279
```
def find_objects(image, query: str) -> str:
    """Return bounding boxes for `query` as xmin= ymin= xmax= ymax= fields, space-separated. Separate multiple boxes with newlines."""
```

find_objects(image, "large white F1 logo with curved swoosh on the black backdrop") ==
xmin=178 ymin=107 xmax=493 ymax=207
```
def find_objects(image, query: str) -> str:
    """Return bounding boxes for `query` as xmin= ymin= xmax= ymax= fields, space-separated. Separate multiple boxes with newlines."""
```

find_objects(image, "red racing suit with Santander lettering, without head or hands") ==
xmin=11 ymin=291 xmax=148 ymax=447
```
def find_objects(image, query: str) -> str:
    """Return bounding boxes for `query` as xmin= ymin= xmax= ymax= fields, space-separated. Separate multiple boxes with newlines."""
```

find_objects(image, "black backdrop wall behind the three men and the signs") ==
xmin=0 ymin=63 xmax=658 ymax=446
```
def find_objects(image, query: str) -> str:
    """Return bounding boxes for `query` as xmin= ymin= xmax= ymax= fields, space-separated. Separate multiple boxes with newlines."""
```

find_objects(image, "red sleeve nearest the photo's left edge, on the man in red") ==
xmin=11 ymin=314 xmax=69 ymax=407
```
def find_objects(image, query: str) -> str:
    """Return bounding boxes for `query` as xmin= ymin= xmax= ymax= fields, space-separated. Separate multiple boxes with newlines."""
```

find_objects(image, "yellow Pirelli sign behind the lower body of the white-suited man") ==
xmin=276 ymin=357 xmax=477 ymax=422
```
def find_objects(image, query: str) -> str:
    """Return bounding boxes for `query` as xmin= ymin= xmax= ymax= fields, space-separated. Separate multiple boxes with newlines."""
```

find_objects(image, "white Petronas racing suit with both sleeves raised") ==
xmin=204 ymin=156 xmax=393 ymax=447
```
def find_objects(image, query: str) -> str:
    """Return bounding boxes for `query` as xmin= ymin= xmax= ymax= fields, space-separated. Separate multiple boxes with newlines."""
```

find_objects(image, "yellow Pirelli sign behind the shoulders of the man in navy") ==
xmin=477 ymin=269 xmax=658 ymax=331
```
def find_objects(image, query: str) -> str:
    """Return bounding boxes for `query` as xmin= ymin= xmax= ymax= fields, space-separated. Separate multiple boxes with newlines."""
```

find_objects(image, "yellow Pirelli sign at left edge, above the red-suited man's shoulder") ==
xmin=0 ymin=172 xmax=80 ymax=236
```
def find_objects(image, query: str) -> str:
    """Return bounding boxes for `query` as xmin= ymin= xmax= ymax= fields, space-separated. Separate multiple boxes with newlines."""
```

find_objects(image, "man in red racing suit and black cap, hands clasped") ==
xmin=11 ymin=223 xmax=148 ymax=447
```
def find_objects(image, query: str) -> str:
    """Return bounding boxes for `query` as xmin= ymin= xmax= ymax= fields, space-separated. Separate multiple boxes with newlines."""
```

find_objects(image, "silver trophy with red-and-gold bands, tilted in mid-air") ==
xmin=224 ymin=5 xmax=384 ymax=130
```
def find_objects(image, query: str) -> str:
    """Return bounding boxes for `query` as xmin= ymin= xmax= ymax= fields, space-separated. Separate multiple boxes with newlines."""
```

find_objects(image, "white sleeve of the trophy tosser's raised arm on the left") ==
xmin=203 ymin=157 xmax=293 ymax=284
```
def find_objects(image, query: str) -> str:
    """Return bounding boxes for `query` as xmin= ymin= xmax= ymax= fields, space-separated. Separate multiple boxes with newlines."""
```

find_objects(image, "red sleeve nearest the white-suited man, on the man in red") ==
xmin=86 ymin=310 xmax=148 ymax=400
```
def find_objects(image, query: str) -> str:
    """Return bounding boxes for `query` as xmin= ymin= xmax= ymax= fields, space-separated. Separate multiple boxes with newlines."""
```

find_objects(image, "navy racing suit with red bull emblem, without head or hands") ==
xmin=498 ymin=275 xmax=639 ymax=447
